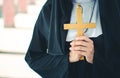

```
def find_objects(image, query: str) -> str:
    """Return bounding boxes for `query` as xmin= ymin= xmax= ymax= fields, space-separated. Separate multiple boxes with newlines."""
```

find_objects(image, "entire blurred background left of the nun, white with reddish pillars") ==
xmin=0 ymin=0 xmax=46 ymax=78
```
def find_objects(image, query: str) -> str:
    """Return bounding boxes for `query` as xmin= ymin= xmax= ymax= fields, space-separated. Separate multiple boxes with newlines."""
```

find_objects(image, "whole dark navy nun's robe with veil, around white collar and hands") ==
xmin=25 ymin=0 xmax=120 ymax=78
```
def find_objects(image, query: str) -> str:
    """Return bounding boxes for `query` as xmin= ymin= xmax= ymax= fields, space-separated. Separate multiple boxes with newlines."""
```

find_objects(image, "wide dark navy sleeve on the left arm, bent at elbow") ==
xmin=25 ymin=0 xmax=69 ymax=78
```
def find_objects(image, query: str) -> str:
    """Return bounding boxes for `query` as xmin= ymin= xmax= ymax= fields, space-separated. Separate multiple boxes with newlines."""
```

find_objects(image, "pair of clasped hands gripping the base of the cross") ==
xmin=69 ymin=36 xmax=94 ymax=63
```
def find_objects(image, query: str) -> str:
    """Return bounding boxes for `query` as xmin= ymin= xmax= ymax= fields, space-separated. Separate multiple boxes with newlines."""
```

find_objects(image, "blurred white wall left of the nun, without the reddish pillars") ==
xmin=0 ymin=0 xmax=46 ymax=78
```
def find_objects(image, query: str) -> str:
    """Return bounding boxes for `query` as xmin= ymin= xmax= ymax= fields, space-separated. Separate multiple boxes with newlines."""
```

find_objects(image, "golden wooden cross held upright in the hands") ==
xmin=64 ymin=5 xmax=96 ymax=60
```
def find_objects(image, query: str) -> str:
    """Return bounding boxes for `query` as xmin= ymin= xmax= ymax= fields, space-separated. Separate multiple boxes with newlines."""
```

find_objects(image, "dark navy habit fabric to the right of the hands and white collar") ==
xmin=93 ymin=0 xmax=120 ymax=78
